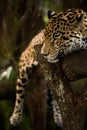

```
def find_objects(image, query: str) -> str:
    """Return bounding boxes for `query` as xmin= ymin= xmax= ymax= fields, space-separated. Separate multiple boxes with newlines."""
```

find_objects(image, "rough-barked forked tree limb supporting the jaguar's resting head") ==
xmin=35 ymin=46 xmax=87 ymax=130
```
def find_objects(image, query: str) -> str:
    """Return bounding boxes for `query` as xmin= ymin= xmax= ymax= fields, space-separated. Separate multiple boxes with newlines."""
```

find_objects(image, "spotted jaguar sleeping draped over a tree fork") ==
xmin=10 ymin=9 xmax=87 ymax=126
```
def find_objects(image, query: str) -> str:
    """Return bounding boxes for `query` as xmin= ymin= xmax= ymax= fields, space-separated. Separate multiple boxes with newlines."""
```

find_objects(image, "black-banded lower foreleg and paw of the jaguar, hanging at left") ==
xmin=10 ymin=67 xmax=32 ymax=126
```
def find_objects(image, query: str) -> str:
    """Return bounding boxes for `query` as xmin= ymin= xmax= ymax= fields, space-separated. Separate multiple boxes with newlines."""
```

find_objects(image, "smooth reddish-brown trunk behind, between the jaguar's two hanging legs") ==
xmin=26 ymin=74 xmax=47 ymax=130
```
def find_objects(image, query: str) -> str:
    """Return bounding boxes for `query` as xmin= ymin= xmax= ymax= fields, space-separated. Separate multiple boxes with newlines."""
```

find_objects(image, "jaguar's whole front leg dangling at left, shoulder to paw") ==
xmin=10 ymin=30 xmax=44 ymax=126
